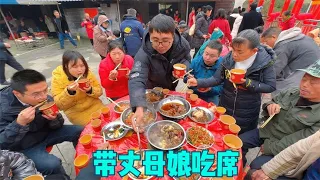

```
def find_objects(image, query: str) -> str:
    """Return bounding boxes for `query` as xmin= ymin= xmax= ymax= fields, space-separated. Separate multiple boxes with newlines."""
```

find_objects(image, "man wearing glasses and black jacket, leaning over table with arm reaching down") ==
xmin=129 ymin=14 xmax=191 ymax=129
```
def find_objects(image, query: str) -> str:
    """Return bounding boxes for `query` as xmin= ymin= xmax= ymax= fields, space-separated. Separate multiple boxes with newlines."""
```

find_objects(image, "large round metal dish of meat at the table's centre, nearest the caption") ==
xmin=147 ymin=120 xmax=186 ymax=151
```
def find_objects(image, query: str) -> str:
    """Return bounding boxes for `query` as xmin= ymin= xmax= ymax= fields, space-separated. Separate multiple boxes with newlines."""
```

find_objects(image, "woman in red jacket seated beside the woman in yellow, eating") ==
xmin=99 ymin=41 xmax=134 ymax=100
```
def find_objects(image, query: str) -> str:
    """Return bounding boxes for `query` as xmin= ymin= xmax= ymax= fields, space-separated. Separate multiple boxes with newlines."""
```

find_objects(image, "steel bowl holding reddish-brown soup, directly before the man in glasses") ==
xmin=157 ymin=96 xmax=191 ymax=119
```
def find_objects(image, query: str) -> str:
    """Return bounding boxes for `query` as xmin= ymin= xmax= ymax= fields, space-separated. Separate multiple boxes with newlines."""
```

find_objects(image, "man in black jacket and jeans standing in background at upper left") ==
xmin=53 ymin=10 xmax=77 ymax=49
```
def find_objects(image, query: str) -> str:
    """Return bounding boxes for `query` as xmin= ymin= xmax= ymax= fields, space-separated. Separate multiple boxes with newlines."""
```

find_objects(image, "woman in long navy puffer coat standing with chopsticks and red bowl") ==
xmin=188 ymin=30 xmax=276 ymax=133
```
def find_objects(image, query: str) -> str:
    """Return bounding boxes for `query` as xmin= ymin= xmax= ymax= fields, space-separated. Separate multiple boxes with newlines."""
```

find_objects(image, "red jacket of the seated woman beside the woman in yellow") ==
xmin=99 ymin=53 xmax=134 ymax=98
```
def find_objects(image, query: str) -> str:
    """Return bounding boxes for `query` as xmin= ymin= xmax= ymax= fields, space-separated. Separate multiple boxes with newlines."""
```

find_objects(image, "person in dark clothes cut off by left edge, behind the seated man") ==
xmin=0 ymin=39 xmax=23 ymax=85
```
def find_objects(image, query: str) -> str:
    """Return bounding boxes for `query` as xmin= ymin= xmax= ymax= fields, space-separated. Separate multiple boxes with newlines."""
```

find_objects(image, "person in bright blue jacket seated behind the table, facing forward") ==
xmin=186 ymin=40 xmax=223 ymax=104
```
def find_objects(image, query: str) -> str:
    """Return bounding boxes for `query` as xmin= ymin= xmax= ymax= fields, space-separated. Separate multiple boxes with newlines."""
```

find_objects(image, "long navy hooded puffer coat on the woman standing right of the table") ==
xmin=198 ymin=46 xmax=276 ymax=133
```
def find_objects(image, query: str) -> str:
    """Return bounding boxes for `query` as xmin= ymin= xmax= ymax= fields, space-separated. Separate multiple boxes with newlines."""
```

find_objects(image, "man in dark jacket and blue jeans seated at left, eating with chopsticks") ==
xmin=0 ymin=69 xmax=83 ymax=175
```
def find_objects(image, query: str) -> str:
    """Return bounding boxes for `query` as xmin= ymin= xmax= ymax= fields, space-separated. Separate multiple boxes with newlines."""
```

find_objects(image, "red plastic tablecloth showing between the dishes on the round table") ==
xmin=75 ymin=91 xmax=243 ymax=180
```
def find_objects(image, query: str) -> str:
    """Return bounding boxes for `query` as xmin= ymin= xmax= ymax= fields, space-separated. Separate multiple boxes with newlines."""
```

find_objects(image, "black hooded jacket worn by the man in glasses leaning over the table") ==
xmin=129 ymin=30 xmax=191 ymax=107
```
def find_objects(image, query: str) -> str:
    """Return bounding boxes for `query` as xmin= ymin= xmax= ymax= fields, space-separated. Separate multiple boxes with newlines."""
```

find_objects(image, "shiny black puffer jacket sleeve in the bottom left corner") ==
xmin=0 ymin=150 xmax=37 ymax=180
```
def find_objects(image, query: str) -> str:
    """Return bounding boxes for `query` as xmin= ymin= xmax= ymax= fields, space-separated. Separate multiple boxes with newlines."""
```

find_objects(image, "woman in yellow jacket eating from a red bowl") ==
xmin=51 ymin=51 xmax=104 ymax=126
